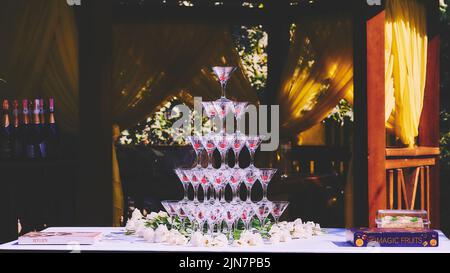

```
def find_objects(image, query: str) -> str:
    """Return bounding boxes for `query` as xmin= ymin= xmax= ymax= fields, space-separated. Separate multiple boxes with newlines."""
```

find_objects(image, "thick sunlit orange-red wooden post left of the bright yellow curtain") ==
xmin=353 ymin=1 xmax=387 ymax=226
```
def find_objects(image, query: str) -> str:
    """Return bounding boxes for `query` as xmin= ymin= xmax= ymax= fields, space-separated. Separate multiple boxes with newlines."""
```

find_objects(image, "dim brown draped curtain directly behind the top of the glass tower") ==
xmin=112 ymin=22 xmax=256 ymax=128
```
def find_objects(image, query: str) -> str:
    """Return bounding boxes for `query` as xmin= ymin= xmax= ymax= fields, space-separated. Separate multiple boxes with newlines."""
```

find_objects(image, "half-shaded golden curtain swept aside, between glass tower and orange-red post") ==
xmin=278 ymin=17 xmax=353 ymax=137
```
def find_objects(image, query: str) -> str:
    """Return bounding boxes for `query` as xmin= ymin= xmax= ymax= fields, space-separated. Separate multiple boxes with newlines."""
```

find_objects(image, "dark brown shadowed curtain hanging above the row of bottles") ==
xmin=0 ymin=0 xmax=78 ymax=133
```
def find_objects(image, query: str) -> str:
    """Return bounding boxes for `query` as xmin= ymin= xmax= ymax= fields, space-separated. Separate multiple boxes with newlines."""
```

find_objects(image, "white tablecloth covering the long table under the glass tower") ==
xmin=0 ymin=227 xmax=450 ymax=253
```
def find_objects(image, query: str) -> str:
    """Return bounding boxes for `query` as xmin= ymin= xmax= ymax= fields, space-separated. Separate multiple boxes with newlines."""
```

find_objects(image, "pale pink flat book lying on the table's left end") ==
xmin=18 ymin=232 xmax=102 ymax=245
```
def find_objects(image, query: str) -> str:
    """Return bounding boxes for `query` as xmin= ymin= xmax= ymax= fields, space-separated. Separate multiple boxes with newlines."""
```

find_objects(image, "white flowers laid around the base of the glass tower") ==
xmin=125 ymin=209 xmax=324 ymax=247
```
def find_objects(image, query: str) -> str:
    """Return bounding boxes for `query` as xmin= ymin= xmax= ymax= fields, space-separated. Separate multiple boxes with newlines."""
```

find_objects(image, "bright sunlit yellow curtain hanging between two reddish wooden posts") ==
xmin=385 ymin=0 xmax=428 ymax=146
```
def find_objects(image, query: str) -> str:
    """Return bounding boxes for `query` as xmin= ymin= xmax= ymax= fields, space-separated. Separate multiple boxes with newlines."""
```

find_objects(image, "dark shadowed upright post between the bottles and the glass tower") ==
xmin=76 ymin=0 xmax=112 ymax=226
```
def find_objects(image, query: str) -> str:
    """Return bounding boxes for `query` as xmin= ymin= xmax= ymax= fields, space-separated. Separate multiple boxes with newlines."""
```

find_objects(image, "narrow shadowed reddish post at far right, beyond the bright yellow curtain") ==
xmin=418 ymin=1 xmax=440 ymax=228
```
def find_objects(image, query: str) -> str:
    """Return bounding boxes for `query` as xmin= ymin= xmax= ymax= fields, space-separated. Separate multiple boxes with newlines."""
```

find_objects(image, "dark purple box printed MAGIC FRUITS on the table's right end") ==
xmin=346 ymin=228 xmax=439 ymax=247
